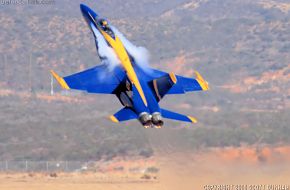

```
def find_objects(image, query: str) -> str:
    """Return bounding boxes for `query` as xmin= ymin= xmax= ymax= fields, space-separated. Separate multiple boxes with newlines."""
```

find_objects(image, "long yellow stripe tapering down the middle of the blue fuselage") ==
xmin=100 ymin=29 xmax=147 ymax=106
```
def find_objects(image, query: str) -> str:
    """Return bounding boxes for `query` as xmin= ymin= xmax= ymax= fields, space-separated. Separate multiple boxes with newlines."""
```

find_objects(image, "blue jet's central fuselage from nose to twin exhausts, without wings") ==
xmin=80 ymin=5 xmax=163 ymax=127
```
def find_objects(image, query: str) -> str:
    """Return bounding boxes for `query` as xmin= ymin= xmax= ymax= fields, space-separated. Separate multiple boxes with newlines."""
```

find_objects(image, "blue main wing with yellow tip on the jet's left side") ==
xmin=51 ymin=64 xmax=125 ymax=94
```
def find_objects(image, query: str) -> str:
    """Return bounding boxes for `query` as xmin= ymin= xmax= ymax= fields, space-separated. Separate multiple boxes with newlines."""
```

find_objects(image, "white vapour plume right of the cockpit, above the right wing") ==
xmin=110 ymin=26 xmax=150 ymax=69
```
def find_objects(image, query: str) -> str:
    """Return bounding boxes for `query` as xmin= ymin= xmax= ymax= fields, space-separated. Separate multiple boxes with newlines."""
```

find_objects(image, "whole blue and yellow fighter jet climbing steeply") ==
xmin=51 ymin=4 xmax=209 ymax=128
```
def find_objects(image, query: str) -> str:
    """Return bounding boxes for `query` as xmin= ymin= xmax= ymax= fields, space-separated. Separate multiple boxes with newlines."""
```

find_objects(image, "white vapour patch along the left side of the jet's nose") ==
xmin=91 ymin=24 xmax=120 ymax=71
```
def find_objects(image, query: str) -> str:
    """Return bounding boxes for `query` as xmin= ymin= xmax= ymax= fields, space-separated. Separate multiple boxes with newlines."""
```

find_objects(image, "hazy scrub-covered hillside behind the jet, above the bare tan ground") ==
xmin=0 ymin=0 xmax=290 ymax=160
